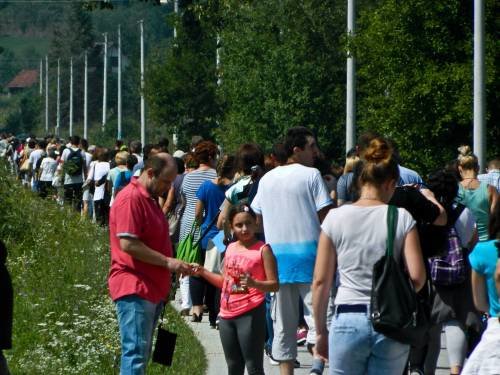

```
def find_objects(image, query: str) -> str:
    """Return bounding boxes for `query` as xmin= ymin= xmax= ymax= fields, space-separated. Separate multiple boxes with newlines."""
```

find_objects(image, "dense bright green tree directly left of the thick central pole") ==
xmin=217 ymin=0 xmax=345 ymax=156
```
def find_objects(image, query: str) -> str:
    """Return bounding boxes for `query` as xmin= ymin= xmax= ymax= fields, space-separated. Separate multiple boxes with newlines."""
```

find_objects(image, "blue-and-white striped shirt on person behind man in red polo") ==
xmin=179 ymin=169 xmax=217 ymax=241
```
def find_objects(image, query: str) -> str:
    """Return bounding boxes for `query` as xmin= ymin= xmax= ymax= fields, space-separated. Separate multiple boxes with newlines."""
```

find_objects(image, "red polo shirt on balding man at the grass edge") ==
xmin=108 ymin=179 xmax=172 ymax=303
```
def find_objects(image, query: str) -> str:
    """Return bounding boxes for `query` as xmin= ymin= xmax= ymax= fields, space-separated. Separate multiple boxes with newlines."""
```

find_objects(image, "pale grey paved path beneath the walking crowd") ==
xmin=172 ymin=296 xmax=450 ymax=375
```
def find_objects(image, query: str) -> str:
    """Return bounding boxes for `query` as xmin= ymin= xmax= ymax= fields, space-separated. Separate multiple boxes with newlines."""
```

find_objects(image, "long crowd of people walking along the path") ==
xmin=0 ymin=127 xmax=500 ymax=375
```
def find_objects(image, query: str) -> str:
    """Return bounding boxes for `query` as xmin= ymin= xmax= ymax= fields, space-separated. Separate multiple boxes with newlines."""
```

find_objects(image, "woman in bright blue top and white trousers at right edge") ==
xmin=462 ymin=204 xmax=500 ymax=375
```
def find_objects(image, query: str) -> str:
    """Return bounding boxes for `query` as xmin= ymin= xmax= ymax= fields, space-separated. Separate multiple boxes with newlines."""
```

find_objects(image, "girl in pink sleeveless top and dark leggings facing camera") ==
xmin=193 ymin=204 xmax=279 ymax=375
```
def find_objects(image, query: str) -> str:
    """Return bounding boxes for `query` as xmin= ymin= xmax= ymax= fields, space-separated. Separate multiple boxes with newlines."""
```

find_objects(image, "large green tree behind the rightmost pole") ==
xmin=354 ymin=0 xmax=500 ymax=172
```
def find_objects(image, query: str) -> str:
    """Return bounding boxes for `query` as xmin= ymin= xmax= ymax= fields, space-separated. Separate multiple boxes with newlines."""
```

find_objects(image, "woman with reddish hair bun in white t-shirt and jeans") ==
xmin=312 ymin=137 xmax=426 ymax=375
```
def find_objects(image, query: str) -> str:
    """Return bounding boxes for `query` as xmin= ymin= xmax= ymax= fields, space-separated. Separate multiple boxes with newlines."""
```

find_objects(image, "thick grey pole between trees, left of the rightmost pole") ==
xmin=345 ymin=0 xmax=356 ymax=152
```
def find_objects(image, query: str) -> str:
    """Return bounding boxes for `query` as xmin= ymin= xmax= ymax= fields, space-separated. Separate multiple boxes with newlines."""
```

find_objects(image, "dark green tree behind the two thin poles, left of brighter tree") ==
xmin=146 ymin=0 xmax=220 ymax=147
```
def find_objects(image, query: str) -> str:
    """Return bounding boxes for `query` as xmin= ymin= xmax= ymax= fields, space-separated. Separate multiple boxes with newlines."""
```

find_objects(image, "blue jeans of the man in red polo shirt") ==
xmin=116 ymin=295 xmax=163 ymax=375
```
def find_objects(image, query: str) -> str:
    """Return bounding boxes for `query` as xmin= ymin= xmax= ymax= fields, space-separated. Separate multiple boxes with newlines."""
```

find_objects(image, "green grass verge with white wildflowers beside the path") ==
xmin=0 ymin=164 xmax=206 ymax=375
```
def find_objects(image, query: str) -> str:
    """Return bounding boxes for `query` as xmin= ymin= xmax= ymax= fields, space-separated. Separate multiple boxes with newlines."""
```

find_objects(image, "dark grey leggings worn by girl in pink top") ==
xmin=219 ymin=302 xmax=266 ymax=375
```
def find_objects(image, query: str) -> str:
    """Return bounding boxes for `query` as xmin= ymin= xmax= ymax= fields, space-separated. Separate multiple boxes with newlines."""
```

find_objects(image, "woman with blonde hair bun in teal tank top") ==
xmin=457 ymin=146 xmax=497 ymax=241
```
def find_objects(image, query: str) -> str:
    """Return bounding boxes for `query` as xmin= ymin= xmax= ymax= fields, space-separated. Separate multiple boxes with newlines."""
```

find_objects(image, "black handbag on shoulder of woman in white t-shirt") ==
xmin=371 ymin=205 xmax=429 ymax=347
